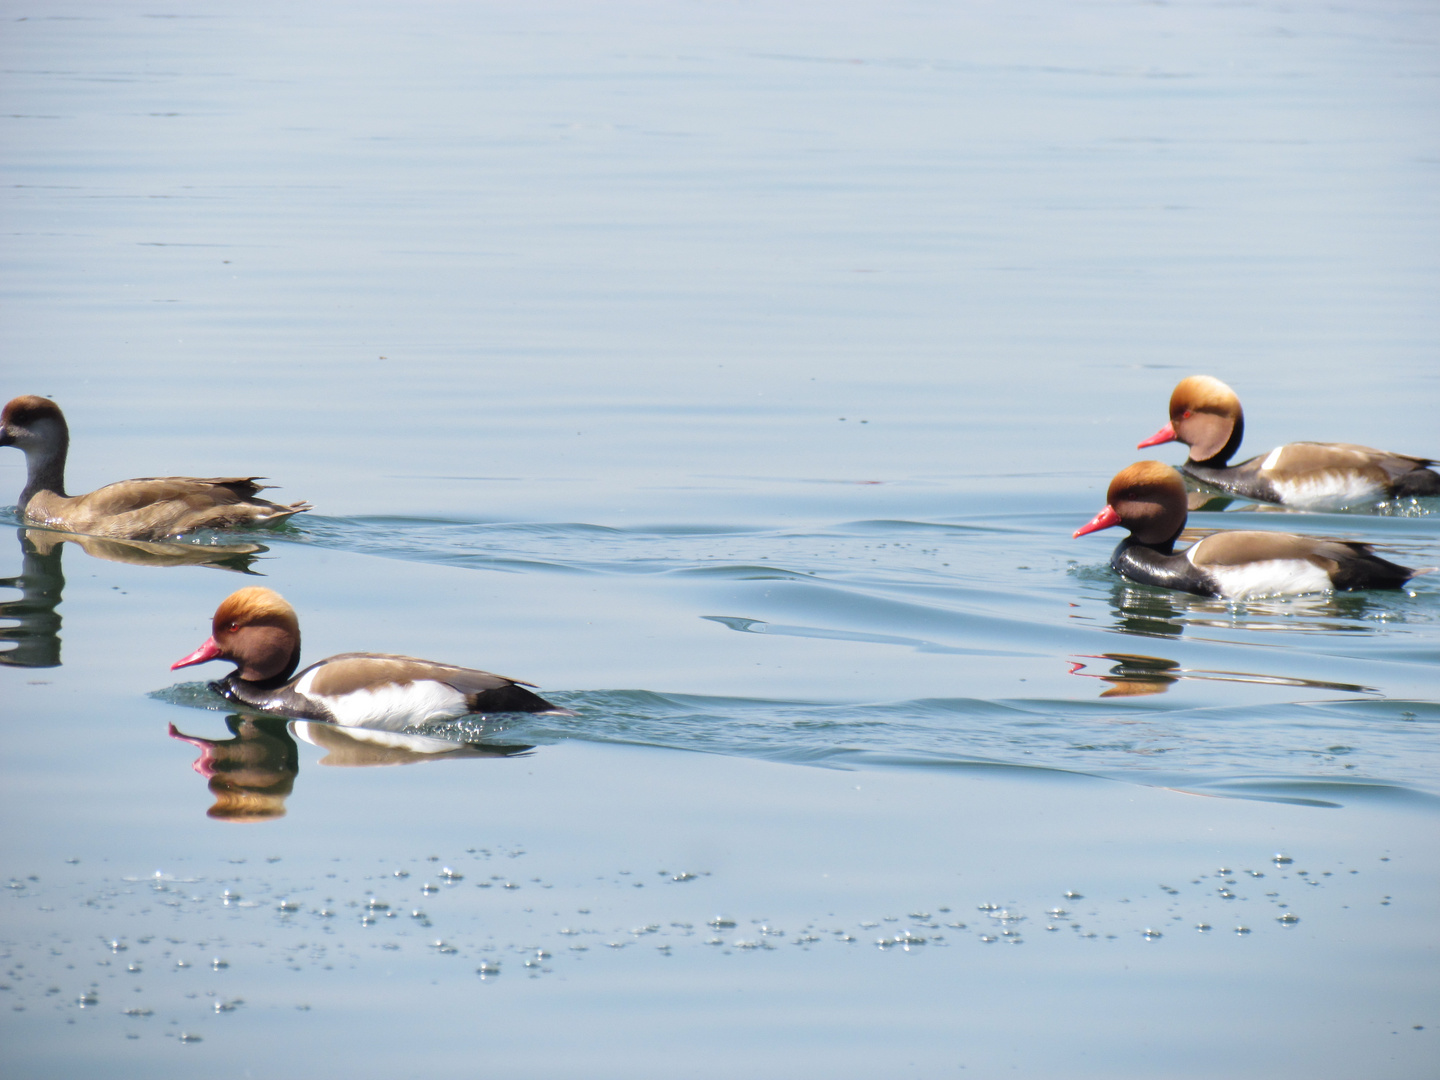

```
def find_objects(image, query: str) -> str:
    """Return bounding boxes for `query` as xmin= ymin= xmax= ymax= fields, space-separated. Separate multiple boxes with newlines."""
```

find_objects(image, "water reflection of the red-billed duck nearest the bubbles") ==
xmin=170 ymin=713 xmax=534 ymax=821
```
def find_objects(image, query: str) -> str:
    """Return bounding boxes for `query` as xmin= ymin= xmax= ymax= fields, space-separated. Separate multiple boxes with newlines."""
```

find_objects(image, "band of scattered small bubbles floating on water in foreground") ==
xmin=0 ymin=848 xmax=1411 ymax=1041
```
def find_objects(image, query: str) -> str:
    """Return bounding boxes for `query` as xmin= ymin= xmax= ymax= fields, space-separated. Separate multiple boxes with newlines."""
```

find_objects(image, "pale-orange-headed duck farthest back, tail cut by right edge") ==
xmin=1136 ymin=374 xmax=1440 ymax=510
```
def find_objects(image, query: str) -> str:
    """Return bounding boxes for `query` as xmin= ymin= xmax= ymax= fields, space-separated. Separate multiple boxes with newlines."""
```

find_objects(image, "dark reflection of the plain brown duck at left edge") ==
xmin=0 ymin=528 xmax=269 ymax=668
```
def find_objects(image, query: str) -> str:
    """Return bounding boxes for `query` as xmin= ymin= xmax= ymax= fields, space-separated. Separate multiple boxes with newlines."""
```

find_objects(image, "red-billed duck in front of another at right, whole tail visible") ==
xmin=1074 ymin=461 xmax=1421 ymax=600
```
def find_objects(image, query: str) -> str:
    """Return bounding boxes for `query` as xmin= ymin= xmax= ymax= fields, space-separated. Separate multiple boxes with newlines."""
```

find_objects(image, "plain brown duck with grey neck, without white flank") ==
xmin=0 ymin=395 xmax=310 ymax=540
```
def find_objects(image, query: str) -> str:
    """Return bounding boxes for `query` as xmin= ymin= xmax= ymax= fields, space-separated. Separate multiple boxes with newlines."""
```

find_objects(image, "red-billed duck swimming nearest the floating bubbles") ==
xmin=170 ymin=586 xmax=575 ymax=732
